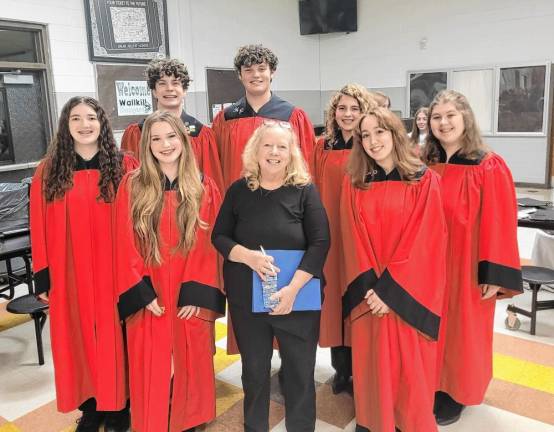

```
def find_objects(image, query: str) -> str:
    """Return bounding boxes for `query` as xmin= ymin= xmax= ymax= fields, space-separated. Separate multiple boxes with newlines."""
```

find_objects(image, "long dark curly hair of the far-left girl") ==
xmin=44 ymin=96 xmax=123 ymax=202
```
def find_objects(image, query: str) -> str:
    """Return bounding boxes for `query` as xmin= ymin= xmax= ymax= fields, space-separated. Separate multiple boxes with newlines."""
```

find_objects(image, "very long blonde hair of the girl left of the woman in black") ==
xmin=131 ymin=111 xmax=208 ymax=265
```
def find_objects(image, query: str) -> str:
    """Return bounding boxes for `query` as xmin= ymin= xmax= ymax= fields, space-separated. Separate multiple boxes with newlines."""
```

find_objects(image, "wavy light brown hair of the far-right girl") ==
xmin=422 ymin=90 xmax=489 ymax=164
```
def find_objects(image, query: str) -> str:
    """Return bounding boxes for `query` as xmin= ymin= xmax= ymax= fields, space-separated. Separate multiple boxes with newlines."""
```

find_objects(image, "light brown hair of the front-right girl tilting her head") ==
xmin=346 ymin=107 xmax=423 ymax=189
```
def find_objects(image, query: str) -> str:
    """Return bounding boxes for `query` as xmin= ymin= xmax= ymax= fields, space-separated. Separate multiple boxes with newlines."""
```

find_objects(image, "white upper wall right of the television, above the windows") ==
xmin=321 ymin=0 xmax=554 ymax=90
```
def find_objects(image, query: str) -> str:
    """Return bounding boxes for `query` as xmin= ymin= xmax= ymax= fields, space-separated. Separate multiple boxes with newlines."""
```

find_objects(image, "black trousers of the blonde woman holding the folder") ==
xmin=230 ymin=305 xmax=320 ymax=432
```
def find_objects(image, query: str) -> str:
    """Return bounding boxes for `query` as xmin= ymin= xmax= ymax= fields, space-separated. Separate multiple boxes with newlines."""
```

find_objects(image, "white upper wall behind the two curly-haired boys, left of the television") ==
xmin=168 ymin=0 xmax=320 ymax=92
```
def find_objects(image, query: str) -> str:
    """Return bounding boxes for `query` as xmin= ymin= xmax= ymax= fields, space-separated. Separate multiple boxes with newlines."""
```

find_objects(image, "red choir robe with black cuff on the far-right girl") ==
xmin=426 ymin=146 xmax=522 ymax=405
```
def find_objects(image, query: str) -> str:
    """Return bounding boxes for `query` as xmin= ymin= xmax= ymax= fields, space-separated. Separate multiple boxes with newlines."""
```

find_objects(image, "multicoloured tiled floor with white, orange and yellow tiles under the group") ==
xmin=0 ymin=190 xmax=554 ymax=432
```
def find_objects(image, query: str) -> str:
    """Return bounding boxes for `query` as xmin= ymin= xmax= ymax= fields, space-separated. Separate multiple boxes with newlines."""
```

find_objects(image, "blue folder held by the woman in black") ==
xmin=252 ymin=250 xmax=321 ymax=312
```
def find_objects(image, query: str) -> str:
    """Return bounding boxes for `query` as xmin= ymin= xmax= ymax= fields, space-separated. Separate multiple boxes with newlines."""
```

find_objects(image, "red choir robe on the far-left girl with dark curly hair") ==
xmin=30 ymin=153 xmax=138 ymax=412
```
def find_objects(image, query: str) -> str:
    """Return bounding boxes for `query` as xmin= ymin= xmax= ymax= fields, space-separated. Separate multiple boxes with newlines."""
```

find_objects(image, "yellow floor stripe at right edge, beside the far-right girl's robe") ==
xmin=493 ymin=353 xmax=554 ymax=394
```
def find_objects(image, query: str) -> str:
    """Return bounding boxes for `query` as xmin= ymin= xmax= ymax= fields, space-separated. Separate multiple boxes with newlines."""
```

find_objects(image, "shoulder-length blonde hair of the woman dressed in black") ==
xmin=242 ymin=120 xmax=311 ymax=191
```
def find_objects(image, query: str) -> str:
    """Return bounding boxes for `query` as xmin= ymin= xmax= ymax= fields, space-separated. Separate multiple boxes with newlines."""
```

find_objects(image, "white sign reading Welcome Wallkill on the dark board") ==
xmin=115 ymin=81 xmax=152 ymax=117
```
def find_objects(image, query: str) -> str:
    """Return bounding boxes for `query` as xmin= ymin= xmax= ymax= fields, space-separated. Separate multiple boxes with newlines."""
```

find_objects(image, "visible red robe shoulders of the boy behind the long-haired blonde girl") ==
xmin=121 ymin=111 xmax=223 ymax=190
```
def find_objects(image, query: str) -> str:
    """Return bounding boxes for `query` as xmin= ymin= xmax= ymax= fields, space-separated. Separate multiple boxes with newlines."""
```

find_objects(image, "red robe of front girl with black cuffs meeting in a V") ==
xmin=341 ymin=168 xmax=447 ymax=432
